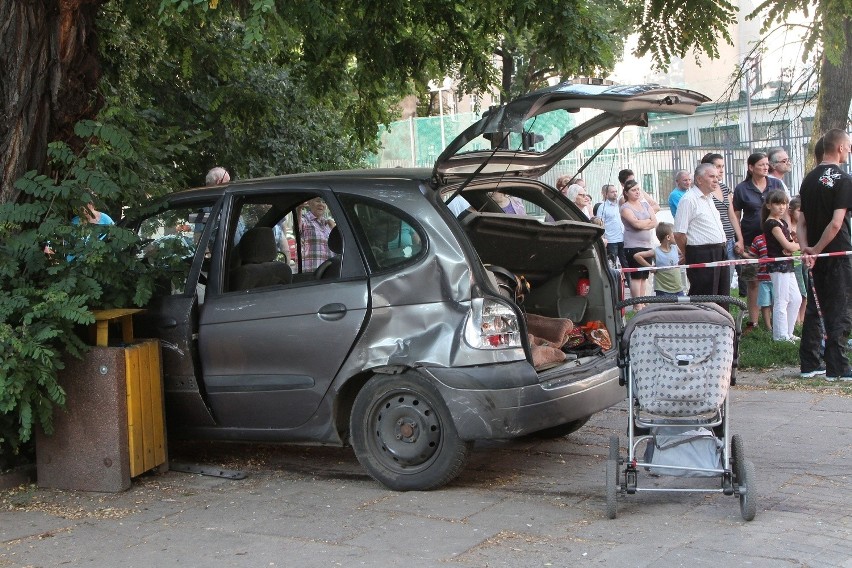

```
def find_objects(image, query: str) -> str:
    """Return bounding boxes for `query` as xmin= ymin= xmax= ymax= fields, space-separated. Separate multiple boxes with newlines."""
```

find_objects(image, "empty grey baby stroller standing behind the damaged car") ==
xmin=606 ymin=296 xmax=757 ymax=521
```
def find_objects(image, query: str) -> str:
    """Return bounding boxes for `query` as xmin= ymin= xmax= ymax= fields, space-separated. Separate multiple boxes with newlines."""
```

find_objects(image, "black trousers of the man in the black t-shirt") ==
xmin=799 ymin=256 xmax=852 ymax=377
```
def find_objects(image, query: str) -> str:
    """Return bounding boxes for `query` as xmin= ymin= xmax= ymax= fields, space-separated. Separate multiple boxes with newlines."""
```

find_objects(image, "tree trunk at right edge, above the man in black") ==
xmin=810 ymin=17 xmax=852 ymax=166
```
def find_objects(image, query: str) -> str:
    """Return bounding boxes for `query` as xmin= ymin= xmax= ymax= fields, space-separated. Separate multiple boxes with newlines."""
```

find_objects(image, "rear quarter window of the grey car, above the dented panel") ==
xmin=349 ymin=202 xmax=425 ymax=270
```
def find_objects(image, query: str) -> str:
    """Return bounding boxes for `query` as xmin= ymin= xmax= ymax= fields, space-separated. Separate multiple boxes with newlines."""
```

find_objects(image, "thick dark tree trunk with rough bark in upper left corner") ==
xmin=0 ymin=0 xmax=105 ymax=204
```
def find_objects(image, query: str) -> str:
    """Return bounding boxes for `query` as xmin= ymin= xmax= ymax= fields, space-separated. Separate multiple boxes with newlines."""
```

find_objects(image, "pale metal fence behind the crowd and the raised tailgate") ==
xmin=368 ymin=113 xmax=849 ymax=210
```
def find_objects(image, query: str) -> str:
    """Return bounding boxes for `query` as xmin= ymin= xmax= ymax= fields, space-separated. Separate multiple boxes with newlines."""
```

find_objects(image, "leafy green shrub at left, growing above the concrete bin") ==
xmin=0 ymin=121 xmax=176 ymax=461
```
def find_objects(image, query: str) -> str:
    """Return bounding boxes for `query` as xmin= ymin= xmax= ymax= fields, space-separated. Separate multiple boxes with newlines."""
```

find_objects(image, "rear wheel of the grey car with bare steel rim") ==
xmin=350 ymin=373 xmax=473 ymax=491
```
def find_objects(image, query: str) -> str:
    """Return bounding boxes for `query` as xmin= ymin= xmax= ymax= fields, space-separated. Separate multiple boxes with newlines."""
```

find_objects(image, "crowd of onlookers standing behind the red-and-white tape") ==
xmin=584 ymin=129 xmax=852 ymax=381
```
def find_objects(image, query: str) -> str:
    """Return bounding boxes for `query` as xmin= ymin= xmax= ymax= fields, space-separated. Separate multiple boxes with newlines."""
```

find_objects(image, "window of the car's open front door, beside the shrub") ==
xmin=137 ymin=206 xmax=216 ymax=296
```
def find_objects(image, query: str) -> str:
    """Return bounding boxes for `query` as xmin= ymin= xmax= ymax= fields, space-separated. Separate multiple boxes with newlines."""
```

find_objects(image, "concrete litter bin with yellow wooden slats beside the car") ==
xmin=36 ymin=340 xmax=166 ymax=492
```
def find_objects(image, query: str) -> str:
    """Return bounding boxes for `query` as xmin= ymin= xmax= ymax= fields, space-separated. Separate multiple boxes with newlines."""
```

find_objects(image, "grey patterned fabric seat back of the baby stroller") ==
xmin=619 ymin=304 xmax=736 ymax=418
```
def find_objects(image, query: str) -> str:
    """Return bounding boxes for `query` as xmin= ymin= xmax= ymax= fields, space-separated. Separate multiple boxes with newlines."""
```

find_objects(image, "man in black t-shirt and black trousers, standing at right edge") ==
xmin=797 ymin=129 xmax=852 ymax=381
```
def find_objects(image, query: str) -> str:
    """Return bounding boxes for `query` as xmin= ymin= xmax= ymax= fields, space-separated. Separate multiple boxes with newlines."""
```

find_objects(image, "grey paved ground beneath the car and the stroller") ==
xmin=0 ymin=370 xmax=852 ymax=568
